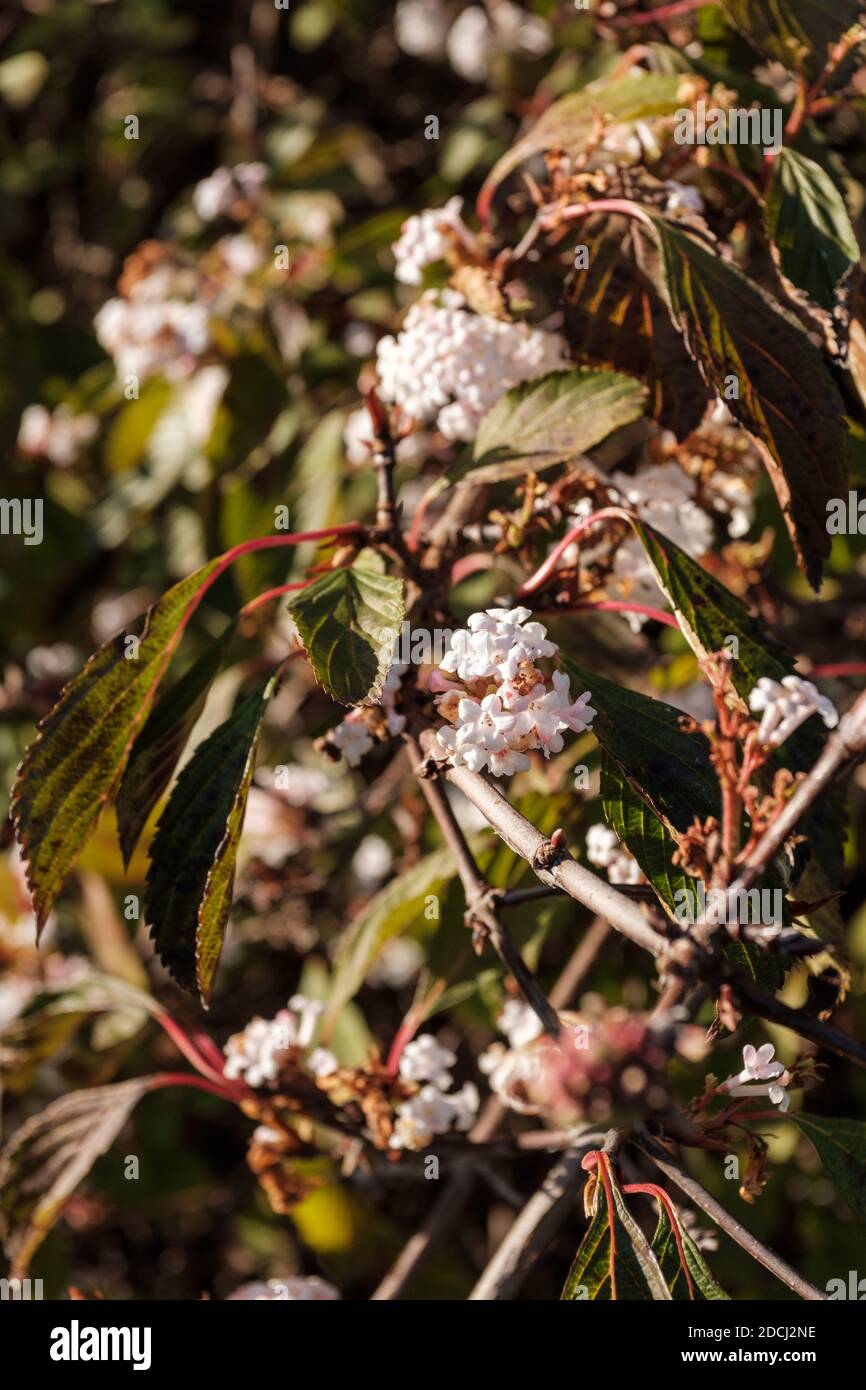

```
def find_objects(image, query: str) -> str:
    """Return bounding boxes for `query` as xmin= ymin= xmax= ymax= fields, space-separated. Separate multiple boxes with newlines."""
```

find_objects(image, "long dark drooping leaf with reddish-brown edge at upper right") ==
xmin=652 ymin=217 xmax=848 ymax=588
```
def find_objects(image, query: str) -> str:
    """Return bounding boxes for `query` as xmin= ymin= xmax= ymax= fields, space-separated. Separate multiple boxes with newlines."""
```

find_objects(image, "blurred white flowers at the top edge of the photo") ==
xmin=395 ymin=0 xmax=550 ymax=82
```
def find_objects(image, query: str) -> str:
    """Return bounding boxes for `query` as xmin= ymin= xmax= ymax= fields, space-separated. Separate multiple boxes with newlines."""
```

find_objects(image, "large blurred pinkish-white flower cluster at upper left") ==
xmin=93 ymin=263 xmax=211 ymax=381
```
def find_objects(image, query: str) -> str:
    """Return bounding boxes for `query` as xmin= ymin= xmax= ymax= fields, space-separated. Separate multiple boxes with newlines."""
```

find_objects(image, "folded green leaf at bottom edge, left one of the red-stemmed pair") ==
xmin=562 ymin=1175 xmax=670 ymax=1302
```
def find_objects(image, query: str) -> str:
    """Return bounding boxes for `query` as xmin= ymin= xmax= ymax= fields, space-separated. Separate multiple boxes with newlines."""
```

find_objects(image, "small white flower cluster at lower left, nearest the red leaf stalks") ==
xmin=224 ymin=994 xmax=338 ymax=1088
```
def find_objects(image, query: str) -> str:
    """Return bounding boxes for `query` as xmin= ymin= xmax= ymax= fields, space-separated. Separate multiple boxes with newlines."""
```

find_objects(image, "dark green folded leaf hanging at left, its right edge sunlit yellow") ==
xmin=145 ymin=674 xmax=278 ymax=1005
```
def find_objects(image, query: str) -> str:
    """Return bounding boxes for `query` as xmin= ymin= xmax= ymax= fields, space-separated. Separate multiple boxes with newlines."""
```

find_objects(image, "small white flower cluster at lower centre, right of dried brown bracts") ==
xmin=389 ymin=1033 xmax=480 ymax=1150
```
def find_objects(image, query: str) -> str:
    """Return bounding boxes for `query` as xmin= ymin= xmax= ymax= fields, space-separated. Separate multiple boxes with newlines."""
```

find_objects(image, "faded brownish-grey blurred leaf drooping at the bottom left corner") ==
xmin=0 ymin=1076 xmax=154 ymax=1277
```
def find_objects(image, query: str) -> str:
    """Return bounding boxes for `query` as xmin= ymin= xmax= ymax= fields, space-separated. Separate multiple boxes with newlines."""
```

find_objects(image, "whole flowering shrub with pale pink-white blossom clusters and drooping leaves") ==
xmin=0 ymin=0 xmax=866 ymax=1301
